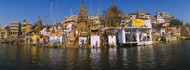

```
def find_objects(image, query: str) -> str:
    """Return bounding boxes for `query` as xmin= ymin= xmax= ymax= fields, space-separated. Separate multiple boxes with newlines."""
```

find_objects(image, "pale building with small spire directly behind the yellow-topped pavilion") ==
xmin=129 ymin=7 xmax=151 ymax=20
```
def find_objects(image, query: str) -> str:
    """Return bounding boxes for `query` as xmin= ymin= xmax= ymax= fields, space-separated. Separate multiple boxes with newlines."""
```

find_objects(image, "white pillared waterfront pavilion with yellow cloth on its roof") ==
xmin=117 ymin=19 xmax=152 ymax=46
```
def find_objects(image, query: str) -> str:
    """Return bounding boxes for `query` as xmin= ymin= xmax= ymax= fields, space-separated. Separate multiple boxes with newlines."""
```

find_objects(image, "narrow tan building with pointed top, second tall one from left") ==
xmin=22 ymin=19 xmax=32 ymax=35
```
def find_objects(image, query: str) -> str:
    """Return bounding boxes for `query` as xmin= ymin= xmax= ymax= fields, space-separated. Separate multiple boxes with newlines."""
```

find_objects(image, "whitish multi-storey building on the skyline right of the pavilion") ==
xmin=154 ymin=12 xmax=174 ymax=24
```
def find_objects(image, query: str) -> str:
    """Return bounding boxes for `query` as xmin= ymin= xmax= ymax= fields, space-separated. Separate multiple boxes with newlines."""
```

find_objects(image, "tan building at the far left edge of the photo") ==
xmin=0 ymin=26 xmax=9 ymax=39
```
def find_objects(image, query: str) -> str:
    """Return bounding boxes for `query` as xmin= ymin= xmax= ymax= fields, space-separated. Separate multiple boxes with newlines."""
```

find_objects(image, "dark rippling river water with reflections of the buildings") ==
xmin=0 ymin=41 xmax=190 ymax=70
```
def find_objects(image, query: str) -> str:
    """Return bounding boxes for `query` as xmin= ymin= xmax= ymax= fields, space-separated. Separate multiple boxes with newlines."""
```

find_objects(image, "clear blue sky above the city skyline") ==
xmin=0 ymin=0 xmax=190 ymax=25
